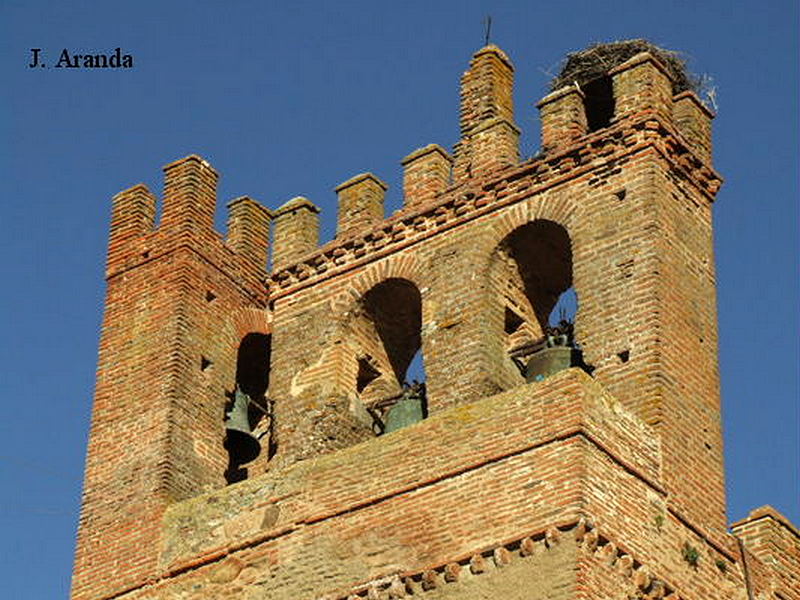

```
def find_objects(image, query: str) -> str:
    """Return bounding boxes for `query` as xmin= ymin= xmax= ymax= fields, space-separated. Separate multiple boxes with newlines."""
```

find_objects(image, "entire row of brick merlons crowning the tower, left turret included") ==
xmin=108 ymin=45 xmax=721 ymax=287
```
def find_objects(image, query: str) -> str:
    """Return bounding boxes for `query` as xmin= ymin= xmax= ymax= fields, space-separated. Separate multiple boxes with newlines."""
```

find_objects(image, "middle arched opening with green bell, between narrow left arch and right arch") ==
xmin=354 ymin=278 xmax=428 ymax=435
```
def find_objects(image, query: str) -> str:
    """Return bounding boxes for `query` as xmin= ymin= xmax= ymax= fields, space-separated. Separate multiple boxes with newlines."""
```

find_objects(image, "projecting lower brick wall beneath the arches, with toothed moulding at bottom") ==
xmin=95 ymin=370 xmax=742 ymax=600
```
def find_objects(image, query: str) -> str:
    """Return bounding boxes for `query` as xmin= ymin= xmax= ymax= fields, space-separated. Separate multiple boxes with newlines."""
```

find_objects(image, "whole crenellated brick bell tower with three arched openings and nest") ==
xmin=72 ymin=40 xmax=800 ymax=600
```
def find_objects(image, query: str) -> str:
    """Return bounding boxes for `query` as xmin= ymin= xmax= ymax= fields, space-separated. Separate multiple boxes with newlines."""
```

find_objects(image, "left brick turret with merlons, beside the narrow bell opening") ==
xmin=72 ymin=156 xmax=268 ymax=598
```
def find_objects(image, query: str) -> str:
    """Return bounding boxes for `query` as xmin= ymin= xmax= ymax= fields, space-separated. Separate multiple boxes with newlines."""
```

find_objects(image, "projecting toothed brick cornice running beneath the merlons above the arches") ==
xmin=269 ymin=111 xmax=722 ymax=297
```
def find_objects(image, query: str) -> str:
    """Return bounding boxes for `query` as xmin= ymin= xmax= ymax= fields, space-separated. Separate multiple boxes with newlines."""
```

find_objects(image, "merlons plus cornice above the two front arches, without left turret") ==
xmin=262 ymin=46 xmax=722 ymax=282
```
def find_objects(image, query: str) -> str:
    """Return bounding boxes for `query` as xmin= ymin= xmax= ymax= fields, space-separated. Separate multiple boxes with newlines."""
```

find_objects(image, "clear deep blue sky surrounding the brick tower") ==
xmin=0 ymin=0 xmax=800 ymax=599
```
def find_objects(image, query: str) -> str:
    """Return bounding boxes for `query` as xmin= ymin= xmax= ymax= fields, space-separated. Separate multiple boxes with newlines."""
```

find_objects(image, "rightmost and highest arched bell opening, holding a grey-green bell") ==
xmin=492 ymin=220 xmax=585 ymax=381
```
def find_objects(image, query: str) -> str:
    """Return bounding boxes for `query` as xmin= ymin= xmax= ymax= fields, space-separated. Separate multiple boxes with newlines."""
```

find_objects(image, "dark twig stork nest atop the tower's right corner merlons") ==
xmin=550 ymin=39 xmax=701 ymax=94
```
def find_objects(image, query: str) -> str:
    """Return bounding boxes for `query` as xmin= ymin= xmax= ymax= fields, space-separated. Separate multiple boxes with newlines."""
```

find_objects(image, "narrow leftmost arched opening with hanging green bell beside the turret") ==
xmin=225 ymin=333 xmax=276 ymax=483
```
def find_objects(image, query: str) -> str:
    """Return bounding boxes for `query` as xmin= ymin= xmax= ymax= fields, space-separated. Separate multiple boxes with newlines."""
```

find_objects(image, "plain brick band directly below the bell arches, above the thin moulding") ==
xmin=160 ymin=369 xmax=661 ymax=573
